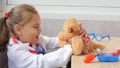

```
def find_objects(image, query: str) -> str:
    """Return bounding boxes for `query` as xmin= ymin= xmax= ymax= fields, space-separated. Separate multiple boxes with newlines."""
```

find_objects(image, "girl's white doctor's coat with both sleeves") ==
xmin=7 ymin=35 xmax=72 ymax=68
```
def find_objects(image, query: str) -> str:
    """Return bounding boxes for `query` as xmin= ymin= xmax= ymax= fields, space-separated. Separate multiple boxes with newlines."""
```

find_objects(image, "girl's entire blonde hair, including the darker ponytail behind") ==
xmin=0 ymin=4 xmax=38 ymax=49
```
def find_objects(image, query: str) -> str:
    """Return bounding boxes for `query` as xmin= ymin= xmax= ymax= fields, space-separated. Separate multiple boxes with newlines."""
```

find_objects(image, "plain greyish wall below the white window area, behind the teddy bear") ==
xmin=41 ymin=19 xmax=120 ymax=37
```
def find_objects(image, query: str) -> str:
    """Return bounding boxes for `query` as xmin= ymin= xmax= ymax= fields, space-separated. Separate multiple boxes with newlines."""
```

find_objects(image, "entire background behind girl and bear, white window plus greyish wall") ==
xmin=0 ymin=0 xmax=120 ymax=37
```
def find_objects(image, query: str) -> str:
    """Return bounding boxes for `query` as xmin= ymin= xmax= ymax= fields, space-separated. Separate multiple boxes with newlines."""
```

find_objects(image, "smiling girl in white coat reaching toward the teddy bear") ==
xmin=0 ymin=4 xmax=86 ymax=68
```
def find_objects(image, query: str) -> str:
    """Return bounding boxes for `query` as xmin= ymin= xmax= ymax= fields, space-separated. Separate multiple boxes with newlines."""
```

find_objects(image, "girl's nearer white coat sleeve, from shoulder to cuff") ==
xmin=8 ymin=45 xmax=72 ymax=68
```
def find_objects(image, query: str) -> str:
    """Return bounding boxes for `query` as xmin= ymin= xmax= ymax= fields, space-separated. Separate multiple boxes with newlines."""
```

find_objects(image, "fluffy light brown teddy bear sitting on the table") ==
xmin=58 ymin=17 xmax=105 ymax=55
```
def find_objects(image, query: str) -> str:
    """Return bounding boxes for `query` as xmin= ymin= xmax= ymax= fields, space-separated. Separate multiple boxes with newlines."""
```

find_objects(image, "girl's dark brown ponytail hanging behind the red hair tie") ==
xmin=0 ymin=17 xmax=9 ymax=51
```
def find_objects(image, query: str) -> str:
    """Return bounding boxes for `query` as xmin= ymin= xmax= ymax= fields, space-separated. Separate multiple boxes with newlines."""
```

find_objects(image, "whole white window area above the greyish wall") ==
xmin=7 ymin=0 xmax=120 ymax=21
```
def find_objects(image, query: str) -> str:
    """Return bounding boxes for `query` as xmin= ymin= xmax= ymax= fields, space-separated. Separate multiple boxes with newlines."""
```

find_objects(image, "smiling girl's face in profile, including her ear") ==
xmin=18 ymin=14 xmax=41 ymax=44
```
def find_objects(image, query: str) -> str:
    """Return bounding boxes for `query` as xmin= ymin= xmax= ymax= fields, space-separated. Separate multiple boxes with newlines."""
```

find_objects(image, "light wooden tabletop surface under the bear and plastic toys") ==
xmin=71 ymin=37 xmax=120 ymax=68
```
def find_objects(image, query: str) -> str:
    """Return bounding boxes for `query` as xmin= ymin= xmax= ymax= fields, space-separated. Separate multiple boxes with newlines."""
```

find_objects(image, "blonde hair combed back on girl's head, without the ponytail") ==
xmin=6 ymin=4 xmax=37 ymax=34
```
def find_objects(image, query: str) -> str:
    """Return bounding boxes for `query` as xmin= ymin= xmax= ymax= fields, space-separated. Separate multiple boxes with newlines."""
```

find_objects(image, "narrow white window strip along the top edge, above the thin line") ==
xmin=8 ymin=0 xmax=120 ymax=7
